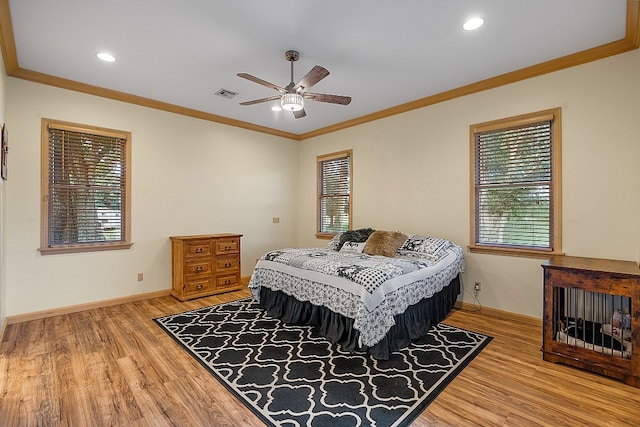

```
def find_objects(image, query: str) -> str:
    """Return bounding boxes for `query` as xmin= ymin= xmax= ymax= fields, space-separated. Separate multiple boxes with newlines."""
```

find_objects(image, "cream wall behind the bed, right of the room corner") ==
xmin=299 ymin=50 xmax=640 ymax=317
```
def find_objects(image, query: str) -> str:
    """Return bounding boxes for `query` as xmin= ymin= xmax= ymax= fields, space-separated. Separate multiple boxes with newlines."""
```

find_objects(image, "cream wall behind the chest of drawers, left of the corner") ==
xmin=6 ymin=78 xmax=298 ymax=316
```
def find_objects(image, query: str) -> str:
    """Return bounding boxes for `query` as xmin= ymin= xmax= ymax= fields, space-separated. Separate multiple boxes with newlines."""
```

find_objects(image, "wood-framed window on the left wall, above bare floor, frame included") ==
xmin=40 ymin=119 xmax=131 ymax=254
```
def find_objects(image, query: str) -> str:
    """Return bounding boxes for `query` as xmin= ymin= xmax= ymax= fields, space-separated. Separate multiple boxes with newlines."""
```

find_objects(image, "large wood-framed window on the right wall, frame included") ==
xmin=469 ymin=108 xmax=561 ymax=256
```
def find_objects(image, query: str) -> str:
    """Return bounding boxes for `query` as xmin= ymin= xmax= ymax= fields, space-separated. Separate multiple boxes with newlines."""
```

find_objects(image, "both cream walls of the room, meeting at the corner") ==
xmin=5 ymin=50 xmax=640 ymax=317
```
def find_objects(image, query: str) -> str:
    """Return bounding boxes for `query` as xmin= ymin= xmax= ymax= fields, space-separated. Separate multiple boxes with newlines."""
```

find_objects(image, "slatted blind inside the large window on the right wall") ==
xmin=475 ymin=119 xmax=553 ymax=250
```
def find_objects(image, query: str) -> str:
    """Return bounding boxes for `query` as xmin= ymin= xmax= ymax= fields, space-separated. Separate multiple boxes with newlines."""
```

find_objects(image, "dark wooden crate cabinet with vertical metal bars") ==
xmin=542 ymin=256 xmax=640 ymax=387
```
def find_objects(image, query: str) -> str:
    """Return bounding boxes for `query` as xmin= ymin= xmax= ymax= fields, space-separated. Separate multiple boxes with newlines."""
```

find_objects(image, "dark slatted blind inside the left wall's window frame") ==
xmin=47 ymin=127 xmax=127 ymax=247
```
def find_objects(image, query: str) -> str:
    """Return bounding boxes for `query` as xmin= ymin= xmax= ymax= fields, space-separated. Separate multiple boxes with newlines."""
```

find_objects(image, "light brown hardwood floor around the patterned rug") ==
xmin=0 ymin=290 xmax=640 ymax=427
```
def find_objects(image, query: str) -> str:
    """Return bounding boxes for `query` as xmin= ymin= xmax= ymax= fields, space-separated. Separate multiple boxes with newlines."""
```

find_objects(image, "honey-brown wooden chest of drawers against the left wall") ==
xmin=170 ymin=233 xmax=242 ymax=301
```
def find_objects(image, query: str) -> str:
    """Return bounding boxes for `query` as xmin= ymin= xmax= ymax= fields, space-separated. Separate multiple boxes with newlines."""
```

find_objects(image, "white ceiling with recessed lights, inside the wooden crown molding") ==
xmin=9 ymin=0 xmax=626 ymax=135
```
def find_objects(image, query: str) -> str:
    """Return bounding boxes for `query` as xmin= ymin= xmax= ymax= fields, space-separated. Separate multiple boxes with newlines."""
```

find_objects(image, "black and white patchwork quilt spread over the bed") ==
xmin=249 ymin=245 xmax=464 ymax=347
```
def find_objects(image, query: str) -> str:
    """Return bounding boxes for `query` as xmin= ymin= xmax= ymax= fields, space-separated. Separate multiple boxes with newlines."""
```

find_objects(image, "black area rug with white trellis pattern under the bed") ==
xmin=154 ymin=298 xmax=491 ymax=427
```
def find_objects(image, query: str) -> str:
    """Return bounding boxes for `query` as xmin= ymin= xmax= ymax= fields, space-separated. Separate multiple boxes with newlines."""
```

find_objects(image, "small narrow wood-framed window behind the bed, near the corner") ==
xmin=316 ymin=150 xmax=352 ymax=238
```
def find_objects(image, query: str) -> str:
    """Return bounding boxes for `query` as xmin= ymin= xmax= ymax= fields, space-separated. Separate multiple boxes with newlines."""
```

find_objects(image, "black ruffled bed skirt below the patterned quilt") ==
xmin=260 ymin=275 xmax=460 ymax=360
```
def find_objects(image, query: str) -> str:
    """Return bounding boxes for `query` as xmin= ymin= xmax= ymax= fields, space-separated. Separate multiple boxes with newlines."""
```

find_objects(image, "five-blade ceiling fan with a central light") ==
xmin=238 ymin=50 xmax=351 ymax=119
